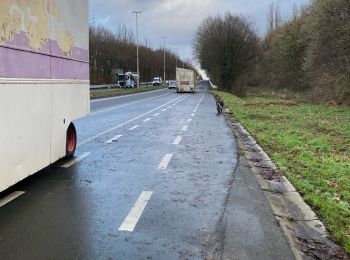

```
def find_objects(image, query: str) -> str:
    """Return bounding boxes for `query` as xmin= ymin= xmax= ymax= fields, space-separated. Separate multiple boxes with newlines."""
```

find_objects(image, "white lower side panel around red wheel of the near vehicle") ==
xmin=51 ymin=81 xmax=90 ymax=162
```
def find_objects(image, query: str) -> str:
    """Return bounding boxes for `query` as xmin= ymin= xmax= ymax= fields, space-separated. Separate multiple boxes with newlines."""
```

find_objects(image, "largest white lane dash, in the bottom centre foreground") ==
xmin=118 ymin=191 xmax=153 ymax=232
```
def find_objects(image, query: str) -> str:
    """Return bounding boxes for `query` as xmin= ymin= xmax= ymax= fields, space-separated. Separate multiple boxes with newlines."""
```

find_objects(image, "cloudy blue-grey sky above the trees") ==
xmin=89 ymin=0 xmax=309 ymax=68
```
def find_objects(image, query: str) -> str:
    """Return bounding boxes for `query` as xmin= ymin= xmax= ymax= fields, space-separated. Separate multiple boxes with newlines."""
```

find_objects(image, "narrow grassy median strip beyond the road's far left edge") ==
xmin=90 ymin=85 xmax=167 ymax=99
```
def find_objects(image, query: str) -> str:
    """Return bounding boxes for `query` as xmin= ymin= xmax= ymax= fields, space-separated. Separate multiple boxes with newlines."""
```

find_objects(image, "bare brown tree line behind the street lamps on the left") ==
xmin=89 ymin=25 xmax=194 ymax=84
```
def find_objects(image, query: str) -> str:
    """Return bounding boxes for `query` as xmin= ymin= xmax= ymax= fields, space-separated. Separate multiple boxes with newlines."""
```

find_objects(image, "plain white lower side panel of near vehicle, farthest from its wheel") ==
xmin=0 ymin=80 xmax=51 ymax=191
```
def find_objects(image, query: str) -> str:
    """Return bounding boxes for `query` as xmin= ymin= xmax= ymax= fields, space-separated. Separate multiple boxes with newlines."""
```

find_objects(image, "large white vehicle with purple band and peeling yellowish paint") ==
xmin=0 ymin=0 xmax=90 ymax=192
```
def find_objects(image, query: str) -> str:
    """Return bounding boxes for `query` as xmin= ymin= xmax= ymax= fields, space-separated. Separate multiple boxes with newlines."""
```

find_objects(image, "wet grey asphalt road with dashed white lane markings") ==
xmin=0 ymin=82 xmax=293 ymax=259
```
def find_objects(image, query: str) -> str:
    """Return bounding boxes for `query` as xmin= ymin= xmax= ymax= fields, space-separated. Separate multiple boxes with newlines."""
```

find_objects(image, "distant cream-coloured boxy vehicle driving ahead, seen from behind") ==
xmin=176 ymin=68 xmax=197 ymax=93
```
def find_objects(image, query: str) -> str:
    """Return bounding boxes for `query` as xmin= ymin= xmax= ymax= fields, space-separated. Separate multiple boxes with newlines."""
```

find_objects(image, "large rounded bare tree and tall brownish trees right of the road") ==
xmin=194 ymin=0 xmax=350 ymax=104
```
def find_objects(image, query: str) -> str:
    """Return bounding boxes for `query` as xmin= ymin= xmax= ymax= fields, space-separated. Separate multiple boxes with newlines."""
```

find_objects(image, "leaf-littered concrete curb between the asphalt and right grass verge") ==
xmin=225 ymin=110 xmax=349 ymax=259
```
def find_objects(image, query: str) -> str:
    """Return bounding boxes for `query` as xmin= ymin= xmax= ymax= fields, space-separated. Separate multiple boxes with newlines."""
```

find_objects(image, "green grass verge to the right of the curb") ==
xmin=214 ymin=91 xmax=350 ymax=253
